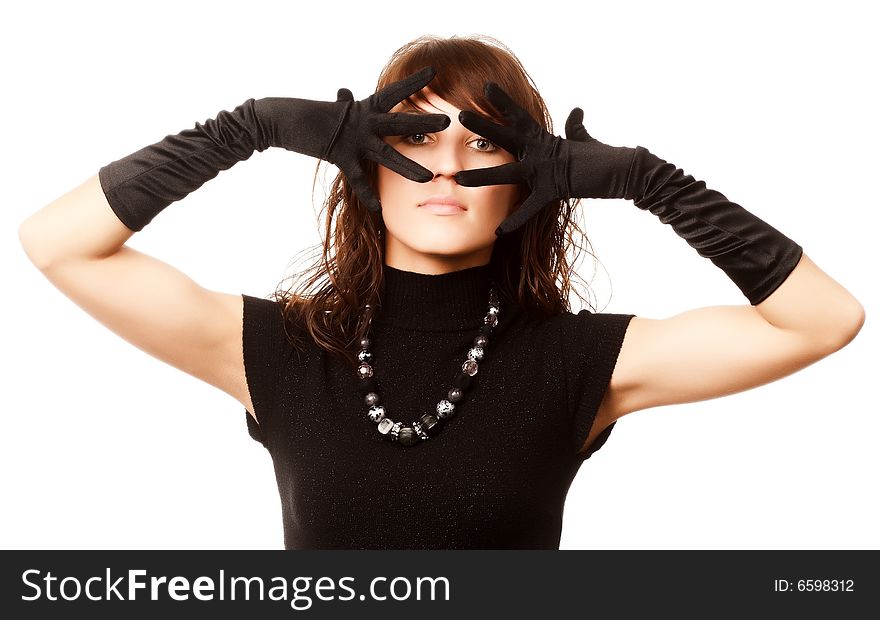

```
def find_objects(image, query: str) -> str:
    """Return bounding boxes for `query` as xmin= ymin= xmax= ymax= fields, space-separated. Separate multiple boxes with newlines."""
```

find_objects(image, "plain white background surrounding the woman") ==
xmin=0 ymin=1 xmax=880 ymax=549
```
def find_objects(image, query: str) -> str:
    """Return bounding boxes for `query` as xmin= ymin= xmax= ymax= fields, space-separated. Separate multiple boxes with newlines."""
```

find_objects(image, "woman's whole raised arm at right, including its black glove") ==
xmin=446 ymin=82 xmax=865 ymax=450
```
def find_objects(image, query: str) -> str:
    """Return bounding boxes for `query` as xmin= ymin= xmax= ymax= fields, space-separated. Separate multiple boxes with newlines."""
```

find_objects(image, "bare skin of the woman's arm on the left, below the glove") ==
xmin=19 ymin=175 xmax=253 ymax=415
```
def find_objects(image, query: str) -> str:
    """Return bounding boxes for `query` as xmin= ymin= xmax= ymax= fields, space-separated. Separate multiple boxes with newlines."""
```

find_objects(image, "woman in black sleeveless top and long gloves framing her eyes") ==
xmin=20 ymin=37 xmax=864 ymax=549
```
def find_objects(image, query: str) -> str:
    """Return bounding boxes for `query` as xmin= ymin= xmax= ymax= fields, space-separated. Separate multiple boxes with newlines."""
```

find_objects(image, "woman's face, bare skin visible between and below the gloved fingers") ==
xmin=377 ymin=89 xmax=519 ymax=274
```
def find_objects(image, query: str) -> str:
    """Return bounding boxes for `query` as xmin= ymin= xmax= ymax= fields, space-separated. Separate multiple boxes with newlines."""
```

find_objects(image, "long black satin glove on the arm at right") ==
xmin=455 ymin=82 xmax=803 ymax=305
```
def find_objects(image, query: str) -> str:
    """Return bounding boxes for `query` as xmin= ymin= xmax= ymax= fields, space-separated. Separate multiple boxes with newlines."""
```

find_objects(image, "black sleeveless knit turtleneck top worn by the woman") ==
xmin=242 ymin=265 xmax=635 ymax=549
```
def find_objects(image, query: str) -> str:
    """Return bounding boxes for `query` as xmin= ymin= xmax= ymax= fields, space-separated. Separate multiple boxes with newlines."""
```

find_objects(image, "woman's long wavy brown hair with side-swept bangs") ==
xmin=275 ymin=35 xmax=600 ymax=368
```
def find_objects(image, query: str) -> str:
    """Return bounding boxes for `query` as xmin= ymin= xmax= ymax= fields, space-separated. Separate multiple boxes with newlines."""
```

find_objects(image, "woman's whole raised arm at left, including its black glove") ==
xmin=19 ymin=67 xmax=449 ymax=426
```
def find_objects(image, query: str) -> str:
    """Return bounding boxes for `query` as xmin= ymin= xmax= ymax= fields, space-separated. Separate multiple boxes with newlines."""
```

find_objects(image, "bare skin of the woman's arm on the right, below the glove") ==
xmin=584 ymin=254 xmax=865 ymax=456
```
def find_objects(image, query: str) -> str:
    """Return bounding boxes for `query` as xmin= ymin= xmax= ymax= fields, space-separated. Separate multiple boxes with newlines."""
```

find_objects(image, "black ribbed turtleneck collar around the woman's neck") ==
xmin=373 ymin=264 xmax=501 ymax=331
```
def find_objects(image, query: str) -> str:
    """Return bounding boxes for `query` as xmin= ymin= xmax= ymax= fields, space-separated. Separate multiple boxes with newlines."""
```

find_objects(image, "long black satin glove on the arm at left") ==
xmin=98 ymin=66 xmax=450 ymax=231
